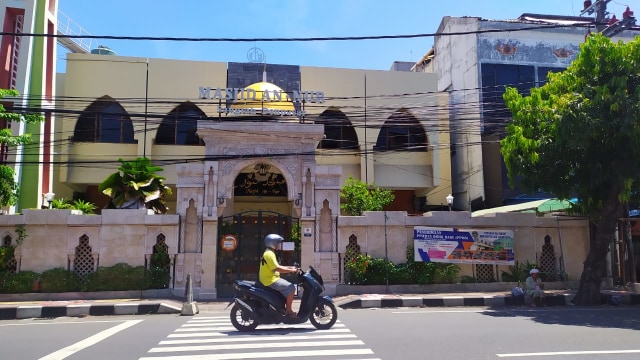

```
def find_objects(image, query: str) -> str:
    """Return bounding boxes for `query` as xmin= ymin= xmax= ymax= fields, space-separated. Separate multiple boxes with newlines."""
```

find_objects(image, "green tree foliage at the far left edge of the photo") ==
xmin=0 ymin=89 xmax=44 ymax=206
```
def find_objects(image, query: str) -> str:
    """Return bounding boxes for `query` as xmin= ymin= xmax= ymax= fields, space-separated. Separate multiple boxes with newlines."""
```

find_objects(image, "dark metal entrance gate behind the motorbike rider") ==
xmin=216 ymin=211 xmax=300 ymax=298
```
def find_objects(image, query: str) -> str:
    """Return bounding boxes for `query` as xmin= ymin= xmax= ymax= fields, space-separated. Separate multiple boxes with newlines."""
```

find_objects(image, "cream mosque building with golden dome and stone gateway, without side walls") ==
xmin=45 ymin=54 xmax=451 ymax=299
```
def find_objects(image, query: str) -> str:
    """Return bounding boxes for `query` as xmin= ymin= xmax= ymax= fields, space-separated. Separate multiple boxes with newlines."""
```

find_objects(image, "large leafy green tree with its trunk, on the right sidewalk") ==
xmin=501 ymin=35 xmax=640 ymax=304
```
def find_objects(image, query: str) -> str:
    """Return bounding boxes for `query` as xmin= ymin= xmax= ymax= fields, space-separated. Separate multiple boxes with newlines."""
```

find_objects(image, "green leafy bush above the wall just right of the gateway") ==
xmin=340 ymin=176 xmax=395 ymax=216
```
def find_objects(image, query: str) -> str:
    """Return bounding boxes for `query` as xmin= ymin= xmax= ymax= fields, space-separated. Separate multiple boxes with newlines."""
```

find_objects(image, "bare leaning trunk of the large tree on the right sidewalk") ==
xmin=573 ymin=189 xmax=622 ymax=305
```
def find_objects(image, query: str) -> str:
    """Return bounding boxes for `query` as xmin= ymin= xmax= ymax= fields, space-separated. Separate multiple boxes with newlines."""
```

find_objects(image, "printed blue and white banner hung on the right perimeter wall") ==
xmin=413 ymin=226 xmax=515 ymax=265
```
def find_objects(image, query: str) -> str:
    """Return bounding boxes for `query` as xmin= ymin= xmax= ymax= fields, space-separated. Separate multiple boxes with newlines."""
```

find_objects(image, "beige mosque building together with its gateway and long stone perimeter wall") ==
xmin=0 ymin=54 xmax=588 ymax=300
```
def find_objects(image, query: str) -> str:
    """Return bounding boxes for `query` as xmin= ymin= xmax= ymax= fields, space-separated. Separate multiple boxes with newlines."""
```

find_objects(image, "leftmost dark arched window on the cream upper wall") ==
xmin=73 ymin=96 xmax=136 ymax=144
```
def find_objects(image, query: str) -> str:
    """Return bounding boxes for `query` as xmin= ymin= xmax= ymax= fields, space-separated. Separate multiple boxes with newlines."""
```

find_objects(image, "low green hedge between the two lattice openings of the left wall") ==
xmin=82 ymin=263 xmax=147 ymax=291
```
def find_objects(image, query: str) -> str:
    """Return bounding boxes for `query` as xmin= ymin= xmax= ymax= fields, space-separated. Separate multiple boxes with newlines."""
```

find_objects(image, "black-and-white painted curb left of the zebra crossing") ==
xmin=0 ymin=303 xmax=182 ymax=320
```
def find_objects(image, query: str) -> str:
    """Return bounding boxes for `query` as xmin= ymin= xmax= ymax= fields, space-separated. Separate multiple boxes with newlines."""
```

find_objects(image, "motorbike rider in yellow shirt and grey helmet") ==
xmin=258 ymin=234 xmax=298 ymax=316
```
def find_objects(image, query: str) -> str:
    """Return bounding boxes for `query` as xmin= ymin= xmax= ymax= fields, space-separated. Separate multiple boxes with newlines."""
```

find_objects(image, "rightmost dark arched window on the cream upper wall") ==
xmin=373 ymin=110 xmax=428 ymax=151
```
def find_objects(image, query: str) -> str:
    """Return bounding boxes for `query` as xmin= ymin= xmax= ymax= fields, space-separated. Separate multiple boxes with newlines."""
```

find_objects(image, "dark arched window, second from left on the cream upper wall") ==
xmin=156 ymin=101 xmax=207 ymax=145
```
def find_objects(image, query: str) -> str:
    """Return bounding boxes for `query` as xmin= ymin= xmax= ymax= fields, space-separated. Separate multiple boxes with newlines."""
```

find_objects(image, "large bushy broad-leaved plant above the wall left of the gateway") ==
xmin=98 ymin=157 xmax=171 ymax=214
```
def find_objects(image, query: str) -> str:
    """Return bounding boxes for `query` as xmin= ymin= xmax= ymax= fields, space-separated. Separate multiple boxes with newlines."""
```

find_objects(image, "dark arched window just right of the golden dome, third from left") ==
xmin=315 ymin=108 xmax=358 ymax=149
